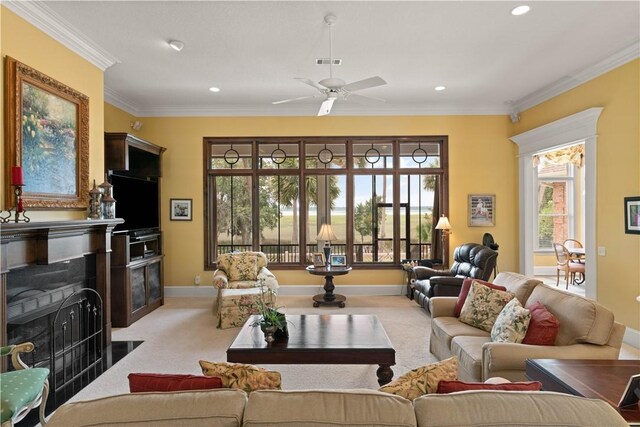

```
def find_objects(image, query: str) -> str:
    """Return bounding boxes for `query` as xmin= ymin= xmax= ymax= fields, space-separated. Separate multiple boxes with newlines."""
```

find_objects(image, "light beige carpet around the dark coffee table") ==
xmin=72 ymin=296 xmax=436 ymax=401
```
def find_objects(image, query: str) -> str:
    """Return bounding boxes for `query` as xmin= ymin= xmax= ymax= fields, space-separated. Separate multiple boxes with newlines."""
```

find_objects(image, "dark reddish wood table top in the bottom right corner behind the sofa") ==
xmin=526 ymin=359 xmax=640 ymax=422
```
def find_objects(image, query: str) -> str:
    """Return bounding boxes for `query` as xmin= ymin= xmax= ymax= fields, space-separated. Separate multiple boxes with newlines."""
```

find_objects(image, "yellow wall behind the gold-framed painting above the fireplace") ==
xmin=0 ymin=7 xmax=104 ymax=221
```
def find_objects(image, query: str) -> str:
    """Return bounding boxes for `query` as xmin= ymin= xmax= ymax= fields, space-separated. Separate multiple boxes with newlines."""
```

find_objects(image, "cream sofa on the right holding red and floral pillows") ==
xmin=429 ymin=273 xmax=625 ymax=381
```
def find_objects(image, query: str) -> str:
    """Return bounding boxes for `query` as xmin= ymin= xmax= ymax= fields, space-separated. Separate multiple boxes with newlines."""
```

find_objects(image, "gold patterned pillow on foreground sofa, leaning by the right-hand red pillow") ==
xmin=378 ymin=356 xmax=458 ymax=400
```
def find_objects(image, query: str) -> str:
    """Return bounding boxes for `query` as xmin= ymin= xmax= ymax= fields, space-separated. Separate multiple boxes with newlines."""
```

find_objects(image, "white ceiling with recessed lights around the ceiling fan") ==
xmin=3 ymin=0 xmax=640 ymax=116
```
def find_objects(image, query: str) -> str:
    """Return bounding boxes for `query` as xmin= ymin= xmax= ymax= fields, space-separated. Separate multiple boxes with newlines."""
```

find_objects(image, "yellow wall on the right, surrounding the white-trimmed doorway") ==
xmin=512 ymin=59 xmax=640 ymax=330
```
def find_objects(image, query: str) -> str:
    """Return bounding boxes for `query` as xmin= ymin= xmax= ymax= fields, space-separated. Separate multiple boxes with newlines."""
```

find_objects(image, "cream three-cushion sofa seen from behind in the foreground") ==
xmin=47 ymin=389 xmax=628 ymax=427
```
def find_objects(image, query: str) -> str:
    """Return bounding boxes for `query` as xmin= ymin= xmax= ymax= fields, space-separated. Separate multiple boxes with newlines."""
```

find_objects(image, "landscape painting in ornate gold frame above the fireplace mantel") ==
xmin=5 ymin=57 xmax=89 ymax=209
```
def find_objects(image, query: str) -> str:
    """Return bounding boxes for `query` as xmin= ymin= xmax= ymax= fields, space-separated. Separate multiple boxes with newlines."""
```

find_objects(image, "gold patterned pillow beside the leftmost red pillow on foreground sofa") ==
xmin=200 ymin=360 xmax=281 ymax=393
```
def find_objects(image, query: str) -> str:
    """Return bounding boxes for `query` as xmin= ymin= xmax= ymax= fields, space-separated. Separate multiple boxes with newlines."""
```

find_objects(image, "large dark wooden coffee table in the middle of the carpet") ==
xmin=227 ymin=314 xmax=396 ymax=385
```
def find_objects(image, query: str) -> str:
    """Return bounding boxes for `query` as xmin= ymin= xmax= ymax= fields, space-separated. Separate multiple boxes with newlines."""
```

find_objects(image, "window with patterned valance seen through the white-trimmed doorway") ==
xmin=536 ymin=156 xmax=575 ymax=251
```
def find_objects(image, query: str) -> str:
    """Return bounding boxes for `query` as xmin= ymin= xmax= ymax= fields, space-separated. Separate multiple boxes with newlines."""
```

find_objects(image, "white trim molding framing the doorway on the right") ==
xmin=510 ymin=107 xmax=603 ymax=299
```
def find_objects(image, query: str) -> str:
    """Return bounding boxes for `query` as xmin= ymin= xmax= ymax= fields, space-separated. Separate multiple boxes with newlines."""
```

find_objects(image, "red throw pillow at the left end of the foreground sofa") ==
xmin=128 ymin=374 xmax=222 ymax=393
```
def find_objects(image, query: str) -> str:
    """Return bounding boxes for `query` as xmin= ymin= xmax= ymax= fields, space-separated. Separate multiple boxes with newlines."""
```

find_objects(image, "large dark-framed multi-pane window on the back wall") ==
xmin=204 ymin=137 xmax=448 ymax=269
